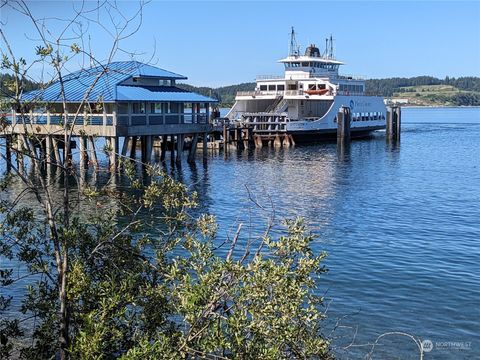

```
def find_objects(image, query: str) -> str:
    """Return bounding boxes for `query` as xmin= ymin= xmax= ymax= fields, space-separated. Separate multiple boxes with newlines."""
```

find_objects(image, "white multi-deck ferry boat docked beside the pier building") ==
xmin=227 ymin=28 xmax=387 ymax=142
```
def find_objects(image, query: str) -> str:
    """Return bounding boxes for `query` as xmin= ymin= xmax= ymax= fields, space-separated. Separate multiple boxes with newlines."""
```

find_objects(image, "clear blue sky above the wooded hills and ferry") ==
xmin=1 ymin=1 xmax=480 ymax=86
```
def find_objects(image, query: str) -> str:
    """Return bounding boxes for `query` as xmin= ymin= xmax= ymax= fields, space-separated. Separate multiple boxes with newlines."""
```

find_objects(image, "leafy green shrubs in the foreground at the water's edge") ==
xmin=0 ymin=164 xmax=330 ymax=359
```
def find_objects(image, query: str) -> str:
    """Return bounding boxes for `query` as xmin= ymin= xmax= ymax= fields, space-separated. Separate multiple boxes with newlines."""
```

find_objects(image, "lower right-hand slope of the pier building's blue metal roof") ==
xmin=117 ymin=85 xmax=218 ymax=102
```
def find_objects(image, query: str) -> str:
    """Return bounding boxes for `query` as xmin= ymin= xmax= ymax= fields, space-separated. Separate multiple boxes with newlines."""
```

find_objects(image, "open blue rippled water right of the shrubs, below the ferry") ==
xmin=1 ymin=108 xmax=480 ymax=359
